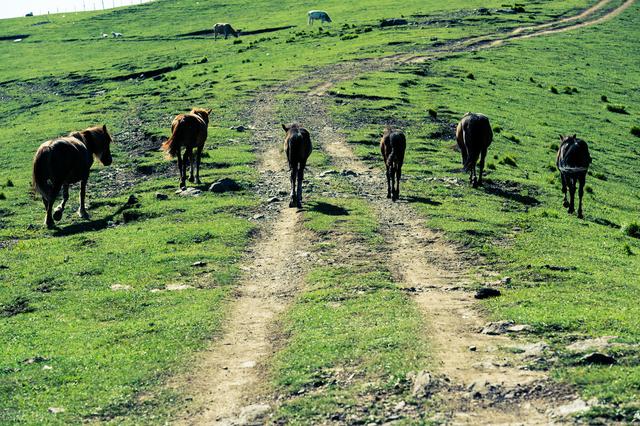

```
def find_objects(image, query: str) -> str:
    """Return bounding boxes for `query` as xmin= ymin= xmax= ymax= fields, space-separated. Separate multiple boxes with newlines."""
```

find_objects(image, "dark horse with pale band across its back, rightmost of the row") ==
xmin=556 ymin=135 xmax=591 ymax=219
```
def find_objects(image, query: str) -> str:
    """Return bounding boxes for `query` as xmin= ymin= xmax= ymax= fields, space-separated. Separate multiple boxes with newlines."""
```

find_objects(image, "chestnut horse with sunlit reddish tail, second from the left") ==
xmin=162 ymin=108 xmax=211 ymax=189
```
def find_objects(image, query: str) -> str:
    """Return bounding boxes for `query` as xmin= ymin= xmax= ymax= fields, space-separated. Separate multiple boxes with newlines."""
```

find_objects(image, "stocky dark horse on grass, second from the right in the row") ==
xmin=456 ymin=112 xmax=493 ymax=188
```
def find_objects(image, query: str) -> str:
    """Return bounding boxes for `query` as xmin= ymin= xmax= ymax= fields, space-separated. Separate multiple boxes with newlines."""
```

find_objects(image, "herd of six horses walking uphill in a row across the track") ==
xmin=32 ymin=108 xmax=591 ymax=228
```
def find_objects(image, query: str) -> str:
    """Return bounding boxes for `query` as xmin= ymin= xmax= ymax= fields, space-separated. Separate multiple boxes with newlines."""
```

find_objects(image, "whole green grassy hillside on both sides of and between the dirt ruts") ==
xmin=0 ymin=0 xmax=640 ymax=424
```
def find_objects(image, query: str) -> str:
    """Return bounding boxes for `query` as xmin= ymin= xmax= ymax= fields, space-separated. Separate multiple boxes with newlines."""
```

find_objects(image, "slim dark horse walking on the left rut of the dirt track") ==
xmin=282 ymin=123 xmax=312 ymax=208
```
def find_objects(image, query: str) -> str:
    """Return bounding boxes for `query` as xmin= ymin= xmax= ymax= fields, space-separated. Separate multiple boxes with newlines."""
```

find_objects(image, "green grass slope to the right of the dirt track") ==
xmin=333 ymin=0 xmax=640 ymax=418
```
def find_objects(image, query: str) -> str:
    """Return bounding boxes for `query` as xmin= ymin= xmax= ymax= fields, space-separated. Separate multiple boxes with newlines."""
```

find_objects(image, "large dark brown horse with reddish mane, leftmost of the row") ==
xmin=32 ymin=125 xmax=113 ymax=228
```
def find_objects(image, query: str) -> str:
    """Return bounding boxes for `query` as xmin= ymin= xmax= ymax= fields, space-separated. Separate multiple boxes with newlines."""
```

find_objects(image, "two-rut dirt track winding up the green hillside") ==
xmin=174 ymin=0 xmax=634 ymax=424
